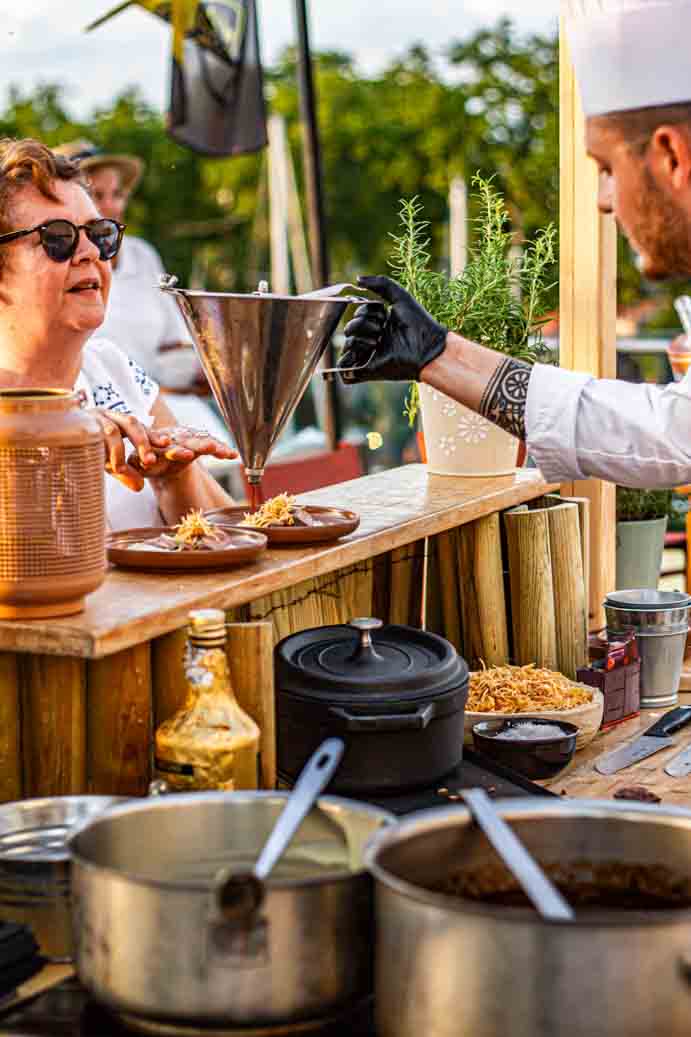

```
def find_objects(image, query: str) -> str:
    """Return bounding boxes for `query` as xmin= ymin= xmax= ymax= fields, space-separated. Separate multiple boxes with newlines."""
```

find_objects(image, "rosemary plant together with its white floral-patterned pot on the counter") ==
xmin=390 ymin=175 xmax=556 ymax=476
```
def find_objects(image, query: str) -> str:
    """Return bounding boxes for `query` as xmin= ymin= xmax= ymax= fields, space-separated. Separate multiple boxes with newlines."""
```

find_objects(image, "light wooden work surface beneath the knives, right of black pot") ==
xmin=545 ymin=693 xmax=691 ymax=808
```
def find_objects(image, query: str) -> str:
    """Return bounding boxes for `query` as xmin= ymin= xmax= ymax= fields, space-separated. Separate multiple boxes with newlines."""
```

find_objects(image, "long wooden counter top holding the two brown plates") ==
xmin=0 ymin=465 xmax=556 ymax=658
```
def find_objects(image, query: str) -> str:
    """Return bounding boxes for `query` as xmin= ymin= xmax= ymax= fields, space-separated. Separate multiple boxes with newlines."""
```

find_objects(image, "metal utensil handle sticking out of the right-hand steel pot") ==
xmin=463 ymin=788 xmax=575 ymax=922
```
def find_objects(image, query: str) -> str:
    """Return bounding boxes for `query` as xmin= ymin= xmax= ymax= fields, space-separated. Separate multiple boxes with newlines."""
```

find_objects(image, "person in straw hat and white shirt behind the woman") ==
xmin=53 ymin=140 xmax=204 ymax=391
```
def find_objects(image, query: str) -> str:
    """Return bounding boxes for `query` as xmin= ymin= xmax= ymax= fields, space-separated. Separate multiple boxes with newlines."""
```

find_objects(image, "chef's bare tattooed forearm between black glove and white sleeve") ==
xmin=421 ymin=332 xmax=531 ymax=440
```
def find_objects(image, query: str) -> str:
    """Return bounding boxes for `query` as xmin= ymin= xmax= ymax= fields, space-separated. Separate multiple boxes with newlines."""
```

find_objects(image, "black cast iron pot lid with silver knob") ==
xmin=276 ymin=618 xmax=468 ymax=703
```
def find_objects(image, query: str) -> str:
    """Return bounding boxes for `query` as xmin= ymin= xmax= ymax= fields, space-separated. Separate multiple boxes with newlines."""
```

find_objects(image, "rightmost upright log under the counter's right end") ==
xmin=547 ymin=503 xmax=587 ymax=680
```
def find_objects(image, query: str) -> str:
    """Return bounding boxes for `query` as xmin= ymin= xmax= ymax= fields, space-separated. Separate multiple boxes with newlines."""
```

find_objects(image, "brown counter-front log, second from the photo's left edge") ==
xmin=20 ymin=655 xmax=87 ymax=796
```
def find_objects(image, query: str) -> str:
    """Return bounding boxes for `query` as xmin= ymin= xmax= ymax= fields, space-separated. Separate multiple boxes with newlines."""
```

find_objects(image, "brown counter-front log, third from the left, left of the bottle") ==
xmin=88 ymin=642 xmax=153 ymax=795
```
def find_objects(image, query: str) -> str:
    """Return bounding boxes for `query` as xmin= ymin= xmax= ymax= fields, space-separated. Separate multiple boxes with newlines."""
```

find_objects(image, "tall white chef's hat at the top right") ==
xmin=564 ymin=0 xmax=691 ymax=115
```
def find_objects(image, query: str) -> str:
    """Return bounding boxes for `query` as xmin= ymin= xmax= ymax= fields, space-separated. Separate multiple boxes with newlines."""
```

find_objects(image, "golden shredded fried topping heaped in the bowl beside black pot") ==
xmin=466 ymin=664 xmax=592 ymax=713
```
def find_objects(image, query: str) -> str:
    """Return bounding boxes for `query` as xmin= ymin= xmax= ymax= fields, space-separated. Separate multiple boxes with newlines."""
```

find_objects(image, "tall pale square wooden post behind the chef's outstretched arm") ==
xmin=559 ymin=21 xmax=616 ymax=629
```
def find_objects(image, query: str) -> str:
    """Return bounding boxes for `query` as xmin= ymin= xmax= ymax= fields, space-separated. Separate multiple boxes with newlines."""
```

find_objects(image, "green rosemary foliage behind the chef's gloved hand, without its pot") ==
xmin=390 ymin=174 xmax=556 ymax=426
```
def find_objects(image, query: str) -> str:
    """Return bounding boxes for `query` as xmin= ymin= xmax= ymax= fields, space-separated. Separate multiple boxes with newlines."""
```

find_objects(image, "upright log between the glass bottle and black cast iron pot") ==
xmin=226 ymin=623 xmax=276 ymax=789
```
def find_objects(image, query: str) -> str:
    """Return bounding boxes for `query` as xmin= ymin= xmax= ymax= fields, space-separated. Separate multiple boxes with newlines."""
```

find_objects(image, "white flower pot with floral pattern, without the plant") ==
xmin=420 ymin=385 xmax=519 ymax=476
